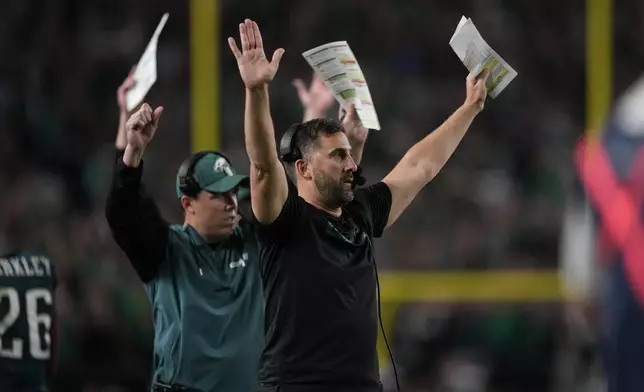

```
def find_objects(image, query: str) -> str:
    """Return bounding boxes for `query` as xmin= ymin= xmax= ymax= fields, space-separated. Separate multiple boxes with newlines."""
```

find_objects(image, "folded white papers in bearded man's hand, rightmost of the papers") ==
xmin=449 ymin=16 xmax=518 ymax=98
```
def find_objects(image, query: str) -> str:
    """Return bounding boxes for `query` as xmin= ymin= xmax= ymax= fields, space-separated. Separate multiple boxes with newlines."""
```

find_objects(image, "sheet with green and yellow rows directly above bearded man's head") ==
xmin=302 ymin=41 xmax=380 ymax=130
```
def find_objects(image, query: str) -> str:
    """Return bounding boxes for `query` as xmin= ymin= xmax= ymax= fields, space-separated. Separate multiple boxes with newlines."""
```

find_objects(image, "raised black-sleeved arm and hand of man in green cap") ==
xmin=105 ymin=104 xmax=169 ymax=282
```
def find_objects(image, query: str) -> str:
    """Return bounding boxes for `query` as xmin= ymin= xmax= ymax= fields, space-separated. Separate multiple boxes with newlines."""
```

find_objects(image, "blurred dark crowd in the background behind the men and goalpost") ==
xmin=0 ymin=0 xmax=644 ymax=391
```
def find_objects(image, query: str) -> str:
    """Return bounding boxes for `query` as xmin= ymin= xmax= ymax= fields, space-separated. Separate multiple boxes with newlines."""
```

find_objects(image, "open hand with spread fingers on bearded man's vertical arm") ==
xmin=228 ymin=19 xmax=284 ymax=89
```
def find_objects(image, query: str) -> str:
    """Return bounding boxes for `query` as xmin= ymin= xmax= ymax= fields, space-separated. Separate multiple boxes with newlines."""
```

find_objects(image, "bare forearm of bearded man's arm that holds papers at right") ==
xmin=400 ymin=105 xmax=479 ymax=183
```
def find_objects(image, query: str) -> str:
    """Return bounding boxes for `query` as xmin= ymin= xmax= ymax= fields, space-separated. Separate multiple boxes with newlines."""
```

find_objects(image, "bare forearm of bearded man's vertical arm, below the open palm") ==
xmin=244 ymin=86 xmax=279 ymax=171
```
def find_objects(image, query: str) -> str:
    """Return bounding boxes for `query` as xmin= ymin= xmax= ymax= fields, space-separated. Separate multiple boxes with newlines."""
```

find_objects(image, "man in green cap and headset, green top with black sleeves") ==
xmin=106 ymin=104 xmax=264 ymax=392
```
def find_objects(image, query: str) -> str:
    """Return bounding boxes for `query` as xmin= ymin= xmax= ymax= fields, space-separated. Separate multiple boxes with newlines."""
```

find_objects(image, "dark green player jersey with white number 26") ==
xmin=0 ymin=251 xmax=56 ymax=392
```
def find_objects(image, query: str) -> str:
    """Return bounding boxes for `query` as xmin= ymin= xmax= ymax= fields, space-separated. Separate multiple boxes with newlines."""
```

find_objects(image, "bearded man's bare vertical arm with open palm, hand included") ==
xmin=228 ymin=19 xmax=288 ymax=225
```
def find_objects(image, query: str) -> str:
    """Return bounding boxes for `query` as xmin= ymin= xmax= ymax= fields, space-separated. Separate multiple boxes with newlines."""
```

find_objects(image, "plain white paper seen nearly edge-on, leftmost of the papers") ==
xmin=125 ymin=12 xmax=170 ymax=111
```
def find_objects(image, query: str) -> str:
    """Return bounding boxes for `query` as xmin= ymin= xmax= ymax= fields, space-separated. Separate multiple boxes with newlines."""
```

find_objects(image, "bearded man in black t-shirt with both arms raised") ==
xmin=229 ymin=19 xmax=489 ymax=392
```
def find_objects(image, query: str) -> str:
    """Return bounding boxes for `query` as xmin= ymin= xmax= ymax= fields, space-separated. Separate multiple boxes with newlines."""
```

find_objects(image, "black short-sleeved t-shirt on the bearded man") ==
xmin=258 ymin=183 xmax=391 ymax=387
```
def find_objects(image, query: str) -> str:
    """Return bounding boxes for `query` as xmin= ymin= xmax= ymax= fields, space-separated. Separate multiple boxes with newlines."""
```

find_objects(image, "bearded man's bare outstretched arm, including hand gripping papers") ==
xmin=383 ymin=69 xmax=489 ymax=227
